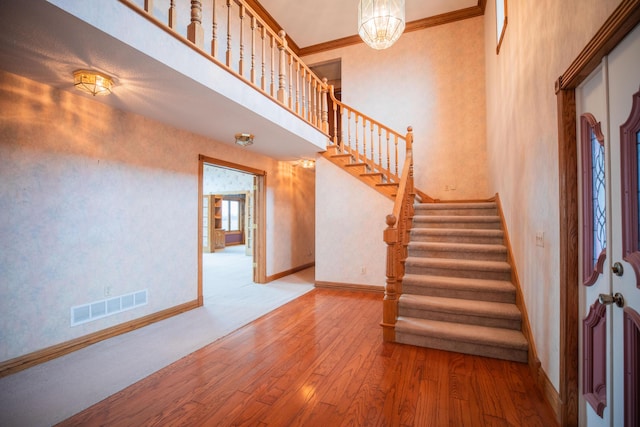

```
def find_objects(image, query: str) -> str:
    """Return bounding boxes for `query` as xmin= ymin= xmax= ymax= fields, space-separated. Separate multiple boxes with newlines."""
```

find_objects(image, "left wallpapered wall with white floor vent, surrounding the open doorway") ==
xmin=0 ymin=72 xmax=315 ymax=361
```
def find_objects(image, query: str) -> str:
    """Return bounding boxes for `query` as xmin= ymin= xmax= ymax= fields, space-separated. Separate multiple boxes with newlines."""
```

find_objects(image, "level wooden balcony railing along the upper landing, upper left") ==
xmin=118 ymin=0 xmax=329 ymax=133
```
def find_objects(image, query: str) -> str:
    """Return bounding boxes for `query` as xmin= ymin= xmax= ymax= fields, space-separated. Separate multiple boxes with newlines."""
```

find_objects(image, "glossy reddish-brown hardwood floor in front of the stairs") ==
xmin=60 ymin=289 xmax=557 ymax=427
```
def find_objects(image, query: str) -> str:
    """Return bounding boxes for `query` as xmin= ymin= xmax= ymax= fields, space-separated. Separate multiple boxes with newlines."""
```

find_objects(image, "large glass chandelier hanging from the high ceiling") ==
xmin=358 ymin=0 xmax=405 ymax=49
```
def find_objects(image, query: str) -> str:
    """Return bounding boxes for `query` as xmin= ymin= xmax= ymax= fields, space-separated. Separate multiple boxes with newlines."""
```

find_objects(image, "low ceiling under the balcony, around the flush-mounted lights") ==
xmin=0 ymin=0 xmax=325 ymax=161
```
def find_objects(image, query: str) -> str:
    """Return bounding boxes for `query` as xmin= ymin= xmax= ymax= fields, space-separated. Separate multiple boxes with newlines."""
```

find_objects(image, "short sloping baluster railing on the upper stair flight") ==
xmin=327 ymin=86 xmax=407 ymax=183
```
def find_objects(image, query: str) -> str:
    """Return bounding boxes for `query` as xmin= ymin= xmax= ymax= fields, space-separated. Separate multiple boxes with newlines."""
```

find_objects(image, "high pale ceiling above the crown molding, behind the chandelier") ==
xmin=259 ymin=0 xmax=478 ymax=48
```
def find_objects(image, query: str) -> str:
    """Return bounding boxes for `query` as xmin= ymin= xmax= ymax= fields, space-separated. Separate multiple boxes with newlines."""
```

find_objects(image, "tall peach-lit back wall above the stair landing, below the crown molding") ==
xmin=303 ymin=17 xmax=493 ymax=199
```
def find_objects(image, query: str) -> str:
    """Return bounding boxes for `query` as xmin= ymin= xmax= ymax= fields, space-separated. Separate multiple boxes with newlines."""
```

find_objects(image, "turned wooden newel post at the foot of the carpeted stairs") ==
xmin=382 ymin=215 xmax=398 ymax=342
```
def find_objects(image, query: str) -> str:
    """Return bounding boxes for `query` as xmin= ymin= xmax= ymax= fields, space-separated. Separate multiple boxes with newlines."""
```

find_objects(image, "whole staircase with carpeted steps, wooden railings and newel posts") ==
xmin=323 ymin=93 xmax=529 ymax=363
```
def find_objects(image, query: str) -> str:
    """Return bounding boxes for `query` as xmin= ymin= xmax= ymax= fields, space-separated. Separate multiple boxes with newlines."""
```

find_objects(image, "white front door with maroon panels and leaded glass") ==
xmin=576 ymin=27 xmax=640 ymax=427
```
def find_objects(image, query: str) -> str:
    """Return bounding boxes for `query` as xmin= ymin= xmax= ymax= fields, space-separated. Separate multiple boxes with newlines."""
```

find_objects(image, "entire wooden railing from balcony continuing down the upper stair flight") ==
xmin=118 ymin=0 xmax=408 ymax=183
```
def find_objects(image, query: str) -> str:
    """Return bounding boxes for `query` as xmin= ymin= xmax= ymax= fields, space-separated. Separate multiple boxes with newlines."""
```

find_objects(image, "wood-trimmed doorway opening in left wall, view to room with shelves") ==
xmin=198 ymin=156 xmax=266 ymax=305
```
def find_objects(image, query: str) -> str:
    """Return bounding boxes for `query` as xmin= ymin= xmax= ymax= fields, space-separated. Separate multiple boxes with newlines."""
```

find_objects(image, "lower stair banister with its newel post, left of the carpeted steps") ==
xmin=381 ymin=127 xmax=416 ymax=342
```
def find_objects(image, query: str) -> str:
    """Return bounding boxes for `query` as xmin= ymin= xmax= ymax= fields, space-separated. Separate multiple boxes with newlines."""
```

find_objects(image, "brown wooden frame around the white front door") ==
xmin=555 ymin=0 xmax=640 ymax=426
